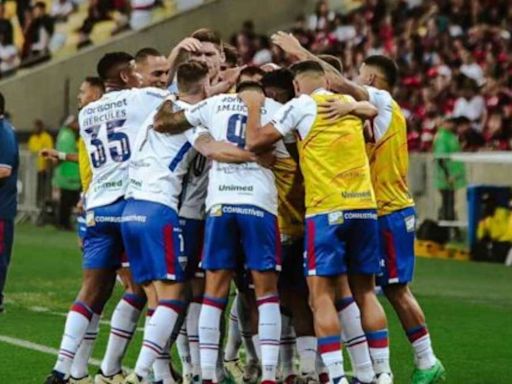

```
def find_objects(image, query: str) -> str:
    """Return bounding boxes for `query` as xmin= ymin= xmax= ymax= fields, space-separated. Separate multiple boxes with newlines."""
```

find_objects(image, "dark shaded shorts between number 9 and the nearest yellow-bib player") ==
xmin=278 ymin=237 xmax=308 ymax=292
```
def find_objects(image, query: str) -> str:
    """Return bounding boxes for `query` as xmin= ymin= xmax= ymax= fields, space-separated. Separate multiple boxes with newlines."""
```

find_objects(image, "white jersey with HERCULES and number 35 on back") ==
xmin=79 ymin=88 xmax=167 ymax=209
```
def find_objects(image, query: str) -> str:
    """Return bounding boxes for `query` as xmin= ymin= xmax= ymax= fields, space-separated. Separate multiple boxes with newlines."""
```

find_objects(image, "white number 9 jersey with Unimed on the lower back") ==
xmin=194 ymin=94 xmax=288 ymax=214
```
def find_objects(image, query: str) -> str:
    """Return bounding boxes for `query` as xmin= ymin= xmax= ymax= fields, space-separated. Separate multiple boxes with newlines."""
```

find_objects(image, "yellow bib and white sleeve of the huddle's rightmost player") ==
xmin=367 ymin=87 xmax=414 ymax=215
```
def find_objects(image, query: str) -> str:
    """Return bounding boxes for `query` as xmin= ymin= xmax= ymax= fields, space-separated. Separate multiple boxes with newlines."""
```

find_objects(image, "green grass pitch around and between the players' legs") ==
xmin=0 ymin=225 xmax=512 ymax=384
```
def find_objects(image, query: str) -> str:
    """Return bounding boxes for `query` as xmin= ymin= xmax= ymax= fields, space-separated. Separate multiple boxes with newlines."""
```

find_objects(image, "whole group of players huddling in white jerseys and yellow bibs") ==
xmin=45 ymin=29 xmax=445 ymax=384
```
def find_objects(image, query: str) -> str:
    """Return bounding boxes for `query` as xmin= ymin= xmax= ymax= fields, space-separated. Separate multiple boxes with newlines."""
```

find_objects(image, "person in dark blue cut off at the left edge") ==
xmin=0 ymin=93 xmax=19 ymax=313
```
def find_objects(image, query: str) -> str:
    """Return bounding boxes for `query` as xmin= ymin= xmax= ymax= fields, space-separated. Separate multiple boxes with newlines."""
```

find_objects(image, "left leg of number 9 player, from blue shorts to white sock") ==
xmin=199 ymin=207 xmax=240 ymax=383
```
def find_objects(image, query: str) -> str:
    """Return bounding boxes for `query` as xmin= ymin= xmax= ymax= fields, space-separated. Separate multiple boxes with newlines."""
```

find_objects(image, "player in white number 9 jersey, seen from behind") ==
xmin=155 ymin=83 xmax=288 ymax=384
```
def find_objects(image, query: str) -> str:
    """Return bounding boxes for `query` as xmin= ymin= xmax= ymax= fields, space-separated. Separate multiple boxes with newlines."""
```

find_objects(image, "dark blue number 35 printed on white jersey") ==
xmin=90 ymin=120 xmax=131 ymax=168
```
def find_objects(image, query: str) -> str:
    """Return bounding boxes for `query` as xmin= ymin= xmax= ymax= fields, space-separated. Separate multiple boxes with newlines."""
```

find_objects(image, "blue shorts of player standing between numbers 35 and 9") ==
xmin=121 ymin=199 xmax=187 ymax=284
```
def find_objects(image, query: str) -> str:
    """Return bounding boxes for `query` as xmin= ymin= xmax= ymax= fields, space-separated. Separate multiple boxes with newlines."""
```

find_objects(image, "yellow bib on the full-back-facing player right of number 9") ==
xmin=298 ymin=93 xmax=375 ymax=215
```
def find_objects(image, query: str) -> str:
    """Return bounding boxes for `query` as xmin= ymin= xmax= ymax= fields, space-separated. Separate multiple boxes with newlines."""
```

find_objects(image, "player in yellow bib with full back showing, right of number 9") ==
xmin=241 ymin=61 xmax=391 ymax=383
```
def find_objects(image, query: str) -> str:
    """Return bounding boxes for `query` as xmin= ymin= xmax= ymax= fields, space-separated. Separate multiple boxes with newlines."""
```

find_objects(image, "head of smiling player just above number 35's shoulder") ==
xmin=135 ymin=48 xmax=170 ymax=89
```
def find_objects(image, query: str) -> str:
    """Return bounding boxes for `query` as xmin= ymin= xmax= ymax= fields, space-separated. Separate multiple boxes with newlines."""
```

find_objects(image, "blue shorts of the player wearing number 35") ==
xmin=82 ymin=200 xmax=125 ymax=269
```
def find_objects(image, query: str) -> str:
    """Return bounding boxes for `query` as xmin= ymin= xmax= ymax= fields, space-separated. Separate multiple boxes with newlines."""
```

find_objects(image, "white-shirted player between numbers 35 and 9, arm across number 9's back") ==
xmin=122 ymin=61 xmax=255 ymax=384
